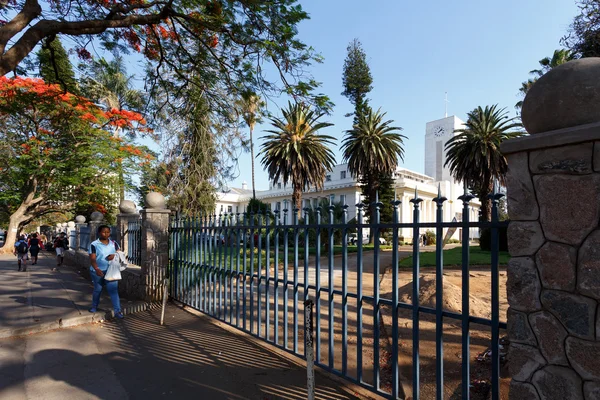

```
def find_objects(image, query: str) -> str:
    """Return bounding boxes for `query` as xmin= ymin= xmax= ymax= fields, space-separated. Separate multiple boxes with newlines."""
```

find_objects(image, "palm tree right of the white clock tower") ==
xmin=444 ymin=104 xmax=522 ymax=221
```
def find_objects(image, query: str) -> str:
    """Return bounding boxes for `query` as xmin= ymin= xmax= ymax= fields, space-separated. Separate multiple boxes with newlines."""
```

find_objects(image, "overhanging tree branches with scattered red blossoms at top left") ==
xmin=0 ymin=0 xmax=331 ymax=117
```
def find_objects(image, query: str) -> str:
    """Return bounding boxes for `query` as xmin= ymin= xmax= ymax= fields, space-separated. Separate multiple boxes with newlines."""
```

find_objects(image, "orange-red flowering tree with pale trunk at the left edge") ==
xmin=0 ymin=77 xmax=150 ymax=251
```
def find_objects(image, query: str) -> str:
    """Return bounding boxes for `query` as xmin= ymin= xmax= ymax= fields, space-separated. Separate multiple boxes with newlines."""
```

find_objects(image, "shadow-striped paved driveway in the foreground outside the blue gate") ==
xmin=0 ymin=305 xmax=378 ymax=400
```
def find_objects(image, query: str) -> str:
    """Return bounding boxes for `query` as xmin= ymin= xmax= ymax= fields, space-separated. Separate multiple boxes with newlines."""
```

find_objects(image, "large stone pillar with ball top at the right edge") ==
xmin=502 ymin=59 xmax=600 ymax=400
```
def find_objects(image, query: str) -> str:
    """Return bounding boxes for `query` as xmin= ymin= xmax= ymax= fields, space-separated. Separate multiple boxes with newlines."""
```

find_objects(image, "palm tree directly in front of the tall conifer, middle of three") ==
xmin=341 ymin=108 xmax=406 ymax=222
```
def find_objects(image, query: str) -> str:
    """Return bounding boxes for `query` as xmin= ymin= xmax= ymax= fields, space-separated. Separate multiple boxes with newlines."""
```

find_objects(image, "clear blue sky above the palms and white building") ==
xmin=221 ymin=0 xmax=578 ymax=190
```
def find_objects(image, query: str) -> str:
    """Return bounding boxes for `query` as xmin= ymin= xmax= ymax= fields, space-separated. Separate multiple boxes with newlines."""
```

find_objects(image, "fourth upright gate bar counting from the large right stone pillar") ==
xmin=410 ymin=188 xmax=423 ymax=400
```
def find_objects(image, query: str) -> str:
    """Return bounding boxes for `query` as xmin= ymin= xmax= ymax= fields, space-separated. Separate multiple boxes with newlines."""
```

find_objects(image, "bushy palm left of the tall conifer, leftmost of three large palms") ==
xmin=259 ymin=103 xmax=335 ymax=217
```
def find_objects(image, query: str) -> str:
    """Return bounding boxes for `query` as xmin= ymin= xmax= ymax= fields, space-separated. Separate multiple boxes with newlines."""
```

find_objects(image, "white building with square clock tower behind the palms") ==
xmin=217 ymin=116 xmax=480 ymax=239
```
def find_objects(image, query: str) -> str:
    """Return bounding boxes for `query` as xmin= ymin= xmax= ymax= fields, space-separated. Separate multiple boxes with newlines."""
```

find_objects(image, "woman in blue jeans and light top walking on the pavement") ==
xmin=90 ymin=225 xmax=123 ymax=319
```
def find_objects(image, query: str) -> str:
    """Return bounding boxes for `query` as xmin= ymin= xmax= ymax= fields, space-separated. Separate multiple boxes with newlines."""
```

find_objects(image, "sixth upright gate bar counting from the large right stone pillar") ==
xmin=371 ymin=193 xmax=383 ymax=391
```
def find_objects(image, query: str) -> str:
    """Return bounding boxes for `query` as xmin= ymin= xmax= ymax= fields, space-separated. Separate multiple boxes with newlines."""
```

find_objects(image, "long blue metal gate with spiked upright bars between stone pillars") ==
xmin=169 ymin=193 xmax=506 ymax=399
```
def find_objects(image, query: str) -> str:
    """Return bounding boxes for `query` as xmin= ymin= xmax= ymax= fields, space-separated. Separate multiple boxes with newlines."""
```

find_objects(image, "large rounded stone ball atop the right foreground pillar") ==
xmin=521 ymin=57 xmax=600 ymax=135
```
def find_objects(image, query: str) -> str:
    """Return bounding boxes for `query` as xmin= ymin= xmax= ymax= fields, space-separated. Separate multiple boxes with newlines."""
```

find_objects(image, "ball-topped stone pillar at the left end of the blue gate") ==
xmin=141 ymin=192 xmax=171 ymax=301
